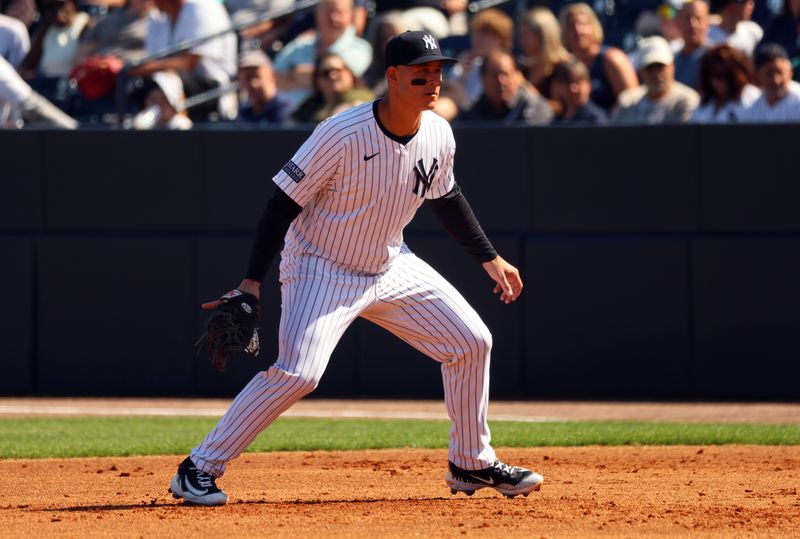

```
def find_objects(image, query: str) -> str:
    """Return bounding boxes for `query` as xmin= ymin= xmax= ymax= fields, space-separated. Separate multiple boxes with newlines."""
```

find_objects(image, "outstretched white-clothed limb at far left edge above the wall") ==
xmin=0 ymin=56 xmax=78 ymax=129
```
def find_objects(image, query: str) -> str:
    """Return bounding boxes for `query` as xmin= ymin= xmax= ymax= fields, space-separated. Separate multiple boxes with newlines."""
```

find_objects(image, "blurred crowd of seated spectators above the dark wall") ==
xmin=0 ymin=0 xmax=800 ymax=129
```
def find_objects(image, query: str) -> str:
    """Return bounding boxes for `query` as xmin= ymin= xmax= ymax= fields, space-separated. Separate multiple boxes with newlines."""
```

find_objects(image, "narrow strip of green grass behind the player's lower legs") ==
xmin=0 ymin=417 xmax=800 ymax=458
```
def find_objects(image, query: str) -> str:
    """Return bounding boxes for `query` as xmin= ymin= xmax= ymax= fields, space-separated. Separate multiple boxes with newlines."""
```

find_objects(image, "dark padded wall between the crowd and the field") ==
xmin=0 ymin=126 xmax=800 ymax=400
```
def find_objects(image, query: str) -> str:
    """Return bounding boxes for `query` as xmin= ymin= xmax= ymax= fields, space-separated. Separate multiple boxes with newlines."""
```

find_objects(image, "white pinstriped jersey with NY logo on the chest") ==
xmin=273 ymin=102 xmax=456 ymax=274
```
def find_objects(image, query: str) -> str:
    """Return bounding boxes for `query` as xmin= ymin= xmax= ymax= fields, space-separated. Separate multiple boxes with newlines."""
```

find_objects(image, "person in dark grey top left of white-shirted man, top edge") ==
xmin=75 ymin=0 xmax=154 ymax=64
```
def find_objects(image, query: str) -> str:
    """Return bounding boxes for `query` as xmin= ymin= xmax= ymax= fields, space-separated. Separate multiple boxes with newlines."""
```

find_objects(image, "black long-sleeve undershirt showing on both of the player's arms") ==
xmin=245 ymin=184 xmax=497 ymax=283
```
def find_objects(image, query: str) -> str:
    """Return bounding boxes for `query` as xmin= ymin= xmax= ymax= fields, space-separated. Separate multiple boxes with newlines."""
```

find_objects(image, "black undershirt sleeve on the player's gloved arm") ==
xmin=245 ymin=187 xmax=303 ymax=283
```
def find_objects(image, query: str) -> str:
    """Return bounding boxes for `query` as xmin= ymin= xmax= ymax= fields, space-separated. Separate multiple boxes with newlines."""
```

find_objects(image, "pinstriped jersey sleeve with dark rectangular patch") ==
xmin=273 ymin=122 xmax=342 ymax=206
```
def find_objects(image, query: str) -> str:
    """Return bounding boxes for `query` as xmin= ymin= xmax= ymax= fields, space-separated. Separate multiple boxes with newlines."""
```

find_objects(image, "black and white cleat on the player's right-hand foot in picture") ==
xmin=444 ymin=460 xmax=544 ymax=498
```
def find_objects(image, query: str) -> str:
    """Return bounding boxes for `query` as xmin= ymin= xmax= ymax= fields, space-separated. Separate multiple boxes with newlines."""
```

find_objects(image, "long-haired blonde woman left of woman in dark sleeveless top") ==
xmin=518 ymin=7 xmax=570 ymax=99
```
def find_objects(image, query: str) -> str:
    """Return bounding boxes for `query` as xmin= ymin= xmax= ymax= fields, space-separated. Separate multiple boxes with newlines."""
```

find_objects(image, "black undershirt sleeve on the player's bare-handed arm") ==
xmin=431 ymin=184 xmax=497 ymax=263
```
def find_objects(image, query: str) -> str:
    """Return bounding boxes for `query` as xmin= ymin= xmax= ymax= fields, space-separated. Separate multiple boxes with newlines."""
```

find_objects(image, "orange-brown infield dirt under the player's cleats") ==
xmin=0 ymin=446 xmax=800 ymax=539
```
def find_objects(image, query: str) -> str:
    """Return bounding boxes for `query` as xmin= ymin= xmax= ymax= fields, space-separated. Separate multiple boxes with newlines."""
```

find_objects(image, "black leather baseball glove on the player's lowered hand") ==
xmin=195 ymin=290 xmax=259 ymax=372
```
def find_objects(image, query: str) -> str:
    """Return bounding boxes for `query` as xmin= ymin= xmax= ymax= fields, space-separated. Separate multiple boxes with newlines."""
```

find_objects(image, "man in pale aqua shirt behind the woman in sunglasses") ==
xmin=274 ymin=0 xmax=372 ymax=110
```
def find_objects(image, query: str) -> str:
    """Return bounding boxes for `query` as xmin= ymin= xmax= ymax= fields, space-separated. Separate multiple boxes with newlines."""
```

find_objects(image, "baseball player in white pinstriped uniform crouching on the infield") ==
xmin=170 ymin=32 xmax=543 ymax=505
